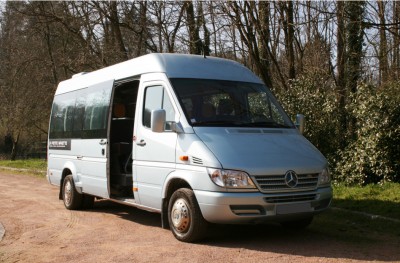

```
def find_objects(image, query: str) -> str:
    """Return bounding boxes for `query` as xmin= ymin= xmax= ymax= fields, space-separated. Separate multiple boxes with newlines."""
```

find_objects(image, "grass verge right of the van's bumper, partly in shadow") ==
xmin=310 ymin=183 xmax=400 ymax=244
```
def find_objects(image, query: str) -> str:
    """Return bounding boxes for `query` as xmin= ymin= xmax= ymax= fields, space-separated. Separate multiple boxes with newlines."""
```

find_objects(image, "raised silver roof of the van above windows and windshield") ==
xmin=56 ymin=53 xmax=262 ymax=95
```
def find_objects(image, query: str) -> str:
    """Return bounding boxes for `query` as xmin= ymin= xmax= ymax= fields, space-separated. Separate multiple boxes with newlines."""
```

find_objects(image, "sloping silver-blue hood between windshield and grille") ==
xmin=194 ymin=127 xmax=327 ymax=175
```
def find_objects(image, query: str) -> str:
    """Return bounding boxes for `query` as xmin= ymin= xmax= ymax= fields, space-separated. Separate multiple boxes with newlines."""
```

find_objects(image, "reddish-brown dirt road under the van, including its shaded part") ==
xmin=0 ymin=171 xmax=400 ymax=262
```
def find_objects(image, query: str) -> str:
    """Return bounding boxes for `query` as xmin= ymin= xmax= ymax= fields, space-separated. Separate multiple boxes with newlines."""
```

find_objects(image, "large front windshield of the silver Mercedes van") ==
xmin=171 ymin=79 xmax=294 ymax=128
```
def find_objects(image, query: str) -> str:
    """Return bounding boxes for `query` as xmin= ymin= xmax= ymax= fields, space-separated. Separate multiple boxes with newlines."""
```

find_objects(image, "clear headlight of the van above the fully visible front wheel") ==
xmin=207 ymin=168 xmax=256 ymax=189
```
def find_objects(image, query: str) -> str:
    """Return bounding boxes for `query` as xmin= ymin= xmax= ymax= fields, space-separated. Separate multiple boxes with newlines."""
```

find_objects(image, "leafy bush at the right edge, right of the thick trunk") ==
xmin=335 ymin=82 xmax=400 ymax=185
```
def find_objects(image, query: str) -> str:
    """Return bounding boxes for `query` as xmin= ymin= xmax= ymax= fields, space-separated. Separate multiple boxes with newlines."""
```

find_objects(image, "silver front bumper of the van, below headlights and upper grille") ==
xmin=194 ymin=187 xmax=332 ymax=224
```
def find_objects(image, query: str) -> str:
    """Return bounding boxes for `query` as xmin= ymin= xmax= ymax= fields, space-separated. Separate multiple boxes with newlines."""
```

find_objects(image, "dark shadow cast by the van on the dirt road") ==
xmin=90 ymin=200 xmax=400 ymax=261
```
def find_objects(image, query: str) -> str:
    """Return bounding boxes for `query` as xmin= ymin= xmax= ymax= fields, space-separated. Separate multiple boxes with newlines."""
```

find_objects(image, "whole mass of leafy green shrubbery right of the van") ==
xmin=277 ymin=73 xmax=400 ymax=185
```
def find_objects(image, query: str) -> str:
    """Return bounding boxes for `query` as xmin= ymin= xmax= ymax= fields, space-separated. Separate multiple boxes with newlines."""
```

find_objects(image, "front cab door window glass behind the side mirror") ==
xmin=143 ymin=86 xmax=175 ymax=130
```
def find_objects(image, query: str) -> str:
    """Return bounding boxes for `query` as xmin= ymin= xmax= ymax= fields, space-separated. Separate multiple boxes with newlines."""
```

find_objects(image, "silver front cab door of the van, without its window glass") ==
xmin=133 ymin=74 xmax=179 ymax=209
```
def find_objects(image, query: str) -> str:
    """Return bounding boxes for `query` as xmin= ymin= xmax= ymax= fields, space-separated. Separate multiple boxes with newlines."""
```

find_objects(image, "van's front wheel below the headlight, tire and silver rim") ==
xmin=168 ymin=188 xmax=207 ymax=243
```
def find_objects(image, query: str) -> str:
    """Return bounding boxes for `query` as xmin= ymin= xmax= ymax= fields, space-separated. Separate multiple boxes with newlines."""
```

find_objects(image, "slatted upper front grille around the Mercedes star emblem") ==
xmin=254 ymin=174 xmax=318 ymax=192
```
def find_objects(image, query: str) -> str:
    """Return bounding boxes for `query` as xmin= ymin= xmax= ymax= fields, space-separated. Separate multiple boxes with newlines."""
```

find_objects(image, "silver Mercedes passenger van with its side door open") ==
xmin=47 ymin=54 xmax=332 ymax=242
